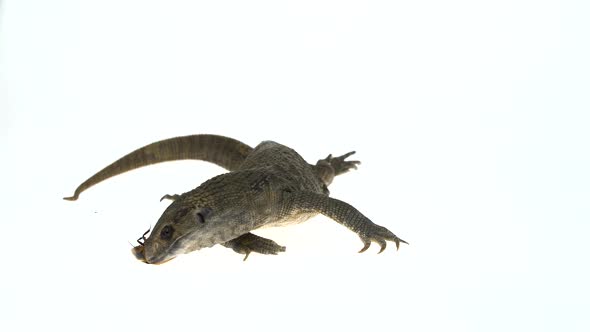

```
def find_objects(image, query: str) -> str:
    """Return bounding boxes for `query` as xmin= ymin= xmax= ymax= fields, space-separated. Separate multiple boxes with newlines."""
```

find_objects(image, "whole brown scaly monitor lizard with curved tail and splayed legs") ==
xmin=64 ymin=135 xmax=407 ymax=264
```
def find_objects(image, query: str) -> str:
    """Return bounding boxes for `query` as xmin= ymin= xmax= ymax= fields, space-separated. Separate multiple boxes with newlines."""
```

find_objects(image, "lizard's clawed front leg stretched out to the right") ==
xmin=283 ymin=191 xmax=408 ymax=253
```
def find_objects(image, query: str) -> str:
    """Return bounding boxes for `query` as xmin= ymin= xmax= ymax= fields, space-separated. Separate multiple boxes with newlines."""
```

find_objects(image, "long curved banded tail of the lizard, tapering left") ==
xmin=64 ymin=135 xmax=252 ymax=201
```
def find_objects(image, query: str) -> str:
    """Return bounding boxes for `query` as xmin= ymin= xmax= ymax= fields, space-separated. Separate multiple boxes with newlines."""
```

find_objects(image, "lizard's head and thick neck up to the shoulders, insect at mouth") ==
xmin=132 ymin=173 xmax=273 ymax=264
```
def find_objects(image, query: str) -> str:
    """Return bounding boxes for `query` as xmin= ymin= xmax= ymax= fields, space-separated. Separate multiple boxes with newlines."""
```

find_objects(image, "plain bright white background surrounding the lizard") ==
xmin=0 ymin=0 xmax=590 ymax=331
